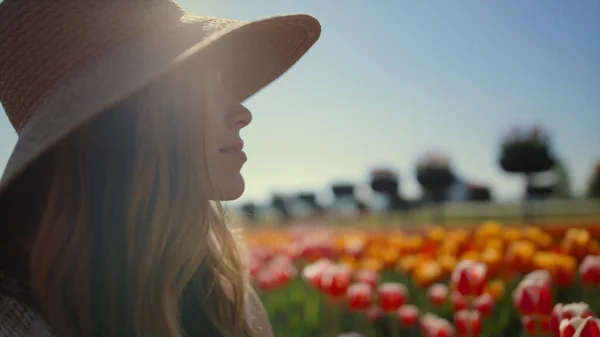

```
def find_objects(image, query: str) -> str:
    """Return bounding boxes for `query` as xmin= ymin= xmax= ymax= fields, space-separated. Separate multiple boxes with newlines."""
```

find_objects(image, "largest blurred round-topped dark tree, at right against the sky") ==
xmin=500 ymin=126 xmax=555 ymax=219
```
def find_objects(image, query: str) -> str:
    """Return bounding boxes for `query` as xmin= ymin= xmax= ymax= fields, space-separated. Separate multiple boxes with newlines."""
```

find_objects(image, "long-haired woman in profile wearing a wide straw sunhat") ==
xmin=0 ymin=0 xmax=320 ymax=337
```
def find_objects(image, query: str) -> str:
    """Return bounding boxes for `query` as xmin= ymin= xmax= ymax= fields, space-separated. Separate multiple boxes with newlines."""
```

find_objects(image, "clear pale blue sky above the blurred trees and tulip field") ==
xmin=0 ymin=0 xmax=600 ymax=203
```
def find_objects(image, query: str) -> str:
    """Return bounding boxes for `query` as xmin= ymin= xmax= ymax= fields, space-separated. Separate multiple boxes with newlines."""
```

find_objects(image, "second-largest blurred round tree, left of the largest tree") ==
xmin=416 ymin=154 xmax=456 ymax=222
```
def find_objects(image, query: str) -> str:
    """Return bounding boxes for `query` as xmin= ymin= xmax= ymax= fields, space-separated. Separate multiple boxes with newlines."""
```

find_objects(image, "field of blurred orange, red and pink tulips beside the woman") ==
xmin=247 ymin=221 xmax=600 ymax=337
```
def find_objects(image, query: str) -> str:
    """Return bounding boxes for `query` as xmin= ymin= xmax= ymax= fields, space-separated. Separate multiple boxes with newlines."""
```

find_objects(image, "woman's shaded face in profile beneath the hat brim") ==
xmin=205 ymin=70 xmax=252 ymax=201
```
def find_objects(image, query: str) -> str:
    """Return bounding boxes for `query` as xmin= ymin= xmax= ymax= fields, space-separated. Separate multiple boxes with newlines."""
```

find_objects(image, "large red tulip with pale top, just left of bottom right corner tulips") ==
xmin=513 ymin=273 xmax=552 ymax=316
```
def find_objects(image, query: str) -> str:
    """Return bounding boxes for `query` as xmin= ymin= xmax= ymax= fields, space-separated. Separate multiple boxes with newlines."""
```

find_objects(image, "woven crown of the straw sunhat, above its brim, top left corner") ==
xmin=0 ymin=0 xmax=185 ymax=132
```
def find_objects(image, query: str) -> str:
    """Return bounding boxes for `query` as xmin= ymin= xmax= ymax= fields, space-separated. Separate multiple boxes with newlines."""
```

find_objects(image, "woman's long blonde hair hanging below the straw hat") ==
xmin=3 ymin=66 xmax=250 ymax=337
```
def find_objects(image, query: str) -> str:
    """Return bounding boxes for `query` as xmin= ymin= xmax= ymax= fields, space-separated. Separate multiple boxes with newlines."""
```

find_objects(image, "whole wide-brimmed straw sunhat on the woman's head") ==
xmin=0 ymin=0 xmax=321 ymax=195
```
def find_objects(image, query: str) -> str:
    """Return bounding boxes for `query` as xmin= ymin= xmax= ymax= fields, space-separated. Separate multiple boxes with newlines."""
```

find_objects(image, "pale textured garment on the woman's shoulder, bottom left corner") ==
xmin=0 ymin=271 xmax=52 ymax=337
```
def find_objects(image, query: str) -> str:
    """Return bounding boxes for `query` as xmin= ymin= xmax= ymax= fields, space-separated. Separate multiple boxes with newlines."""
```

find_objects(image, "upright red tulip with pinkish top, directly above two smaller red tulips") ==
xmin=452 ymin=260 xmax=487 ymax=296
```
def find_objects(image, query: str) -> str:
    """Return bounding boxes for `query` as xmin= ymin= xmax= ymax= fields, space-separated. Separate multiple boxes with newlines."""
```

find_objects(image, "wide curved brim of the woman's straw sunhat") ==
xmin=0 ymin=14 xmax=321 ymax=196
